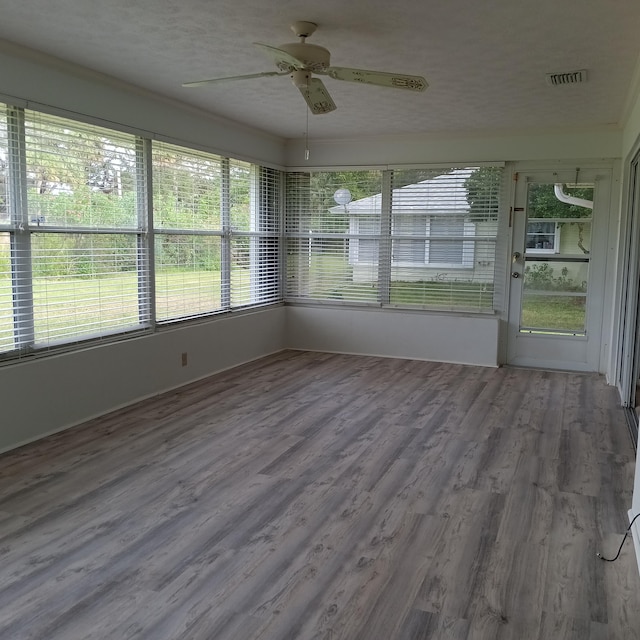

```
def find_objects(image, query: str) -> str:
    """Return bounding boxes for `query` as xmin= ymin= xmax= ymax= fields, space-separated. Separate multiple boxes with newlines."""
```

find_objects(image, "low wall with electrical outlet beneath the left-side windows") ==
xmin=0 ymin=306 xmax=285 ymax=451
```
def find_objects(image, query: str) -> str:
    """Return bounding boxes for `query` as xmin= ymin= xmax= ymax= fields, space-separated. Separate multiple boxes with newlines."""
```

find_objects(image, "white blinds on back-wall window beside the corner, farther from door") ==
xmin=286 ymin=170 xmax=382 ymax=303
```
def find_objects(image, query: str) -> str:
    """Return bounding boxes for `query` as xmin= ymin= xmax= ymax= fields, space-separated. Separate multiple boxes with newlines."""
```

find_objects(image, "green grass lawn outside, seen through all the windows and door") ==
xmin=0 ymin=269 xmax=585 ymax=351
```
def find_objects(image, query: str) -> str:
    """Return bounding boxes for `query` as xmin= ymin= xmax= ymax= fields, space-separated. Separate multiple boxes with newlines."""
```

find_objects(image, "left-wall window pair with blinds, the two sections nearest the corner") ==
xmin=153 ymin=143 xmax=280 ymax=321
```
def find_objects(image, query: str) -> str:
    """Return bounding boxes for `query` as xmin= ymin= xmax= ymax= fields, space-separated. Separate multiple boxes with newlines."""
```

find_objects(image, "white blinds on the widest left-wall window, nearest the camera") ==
xmin=18 ymin=111 xmax=148 ymax=350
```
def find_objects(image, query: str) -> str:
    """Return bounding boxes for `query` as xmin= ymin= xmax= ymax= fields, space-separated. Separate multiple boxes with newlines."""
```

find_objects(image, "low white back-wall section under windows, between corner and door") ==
xmin=285 ymin=306 xmax=499 ymax=367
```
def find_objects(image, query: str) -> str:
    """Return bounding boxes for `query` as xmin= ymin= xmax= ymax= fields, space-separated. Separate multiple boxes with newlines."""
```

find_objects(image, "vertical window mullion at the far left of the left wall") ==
xmin=7 ymin=107 xmax=35 ymax=349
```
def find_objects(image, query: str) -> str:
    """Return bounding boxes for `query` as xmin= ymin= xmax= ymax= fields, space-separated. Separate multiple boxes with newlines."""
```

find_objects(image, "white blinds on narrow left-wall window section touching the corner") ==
xmin=229 ymin=166 xmax=281 ymax=308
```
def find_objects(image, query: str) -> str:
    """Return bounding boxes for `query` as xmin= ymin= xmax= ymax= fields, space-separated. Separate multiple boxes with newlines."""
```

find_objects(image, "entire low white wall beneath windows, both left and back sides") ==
xmin=0 ymin=306 xmax=498 ymax=451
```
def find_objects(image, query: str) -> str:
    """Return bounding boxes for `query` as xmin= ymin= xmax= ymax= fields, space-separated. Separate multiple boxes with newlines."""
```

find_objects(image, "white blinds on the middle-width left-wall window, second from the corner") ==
xmin=152 ymin=142 xmax=223 ymax=321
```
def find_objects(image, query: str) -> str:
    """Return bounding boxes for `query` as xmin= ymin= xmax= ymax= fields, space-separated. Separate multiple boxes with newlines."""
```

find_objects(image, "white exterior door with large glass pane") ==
xmin=507 ymin=169 xmax=610 ymax=371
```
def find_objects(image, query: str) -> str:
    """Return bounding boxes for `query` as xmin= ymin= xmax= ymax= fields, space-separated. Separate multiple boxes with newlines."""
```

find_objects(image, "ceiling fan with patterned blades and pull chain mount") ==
xmin=182 ymin=21 xmax=427 ymax=114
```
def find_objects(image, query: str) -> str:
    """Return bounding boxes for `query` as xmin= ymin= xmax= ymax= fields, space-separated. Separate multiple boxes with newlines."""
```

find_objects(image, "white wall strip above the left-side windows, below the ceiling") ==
xmin=0 ymin=40 xmax=284 ymax=166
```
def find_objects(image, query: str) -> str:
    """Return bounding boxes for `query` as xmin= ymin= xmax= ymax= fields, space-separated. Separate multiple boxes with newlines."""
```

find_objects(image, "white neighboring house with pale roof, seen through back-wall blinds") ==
xmin=340 ymin=169 xmax=497 ymax=282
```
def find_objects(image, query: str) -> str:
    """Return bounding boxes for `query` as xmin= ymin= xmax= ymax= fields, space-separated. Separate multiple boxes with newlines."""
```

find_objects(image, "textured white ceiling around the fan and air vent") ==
xmin=0 ymin=0 xmax=640 ymax=138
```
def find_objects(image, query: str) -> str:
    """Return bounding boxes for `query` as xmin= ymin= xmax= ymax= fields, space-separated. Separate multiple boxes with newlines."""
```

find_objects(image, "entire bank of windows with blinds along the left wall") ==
xmin=0 ymin=101 xmax=281 ymax=357
